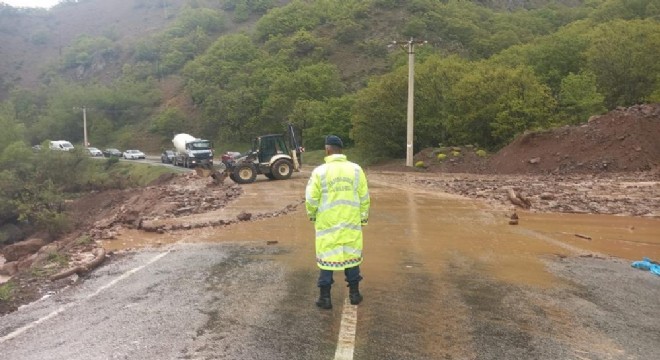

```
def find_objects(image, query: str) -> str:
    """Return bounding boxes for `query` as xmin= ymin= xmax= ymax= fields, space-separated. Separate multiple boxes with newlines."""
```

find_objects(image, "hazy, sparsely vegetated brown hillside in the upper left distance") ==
xmin=0 ymin=0 xmax=193 ymax=94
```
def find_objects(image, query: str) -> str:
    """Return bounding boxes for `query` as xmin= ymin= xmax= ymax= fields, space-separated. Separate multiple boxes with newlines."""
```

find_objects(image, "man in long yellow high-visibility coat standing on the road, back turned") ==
xmin=305 ymin=135 xmax=370 ymax=309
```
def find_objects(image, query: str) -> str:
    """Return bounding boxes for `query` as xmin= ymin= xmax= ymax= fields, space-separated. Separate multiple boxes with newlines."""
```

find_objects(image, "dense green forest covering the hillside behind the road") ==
xmin=0 ymin=0 xmax=660 ymax=239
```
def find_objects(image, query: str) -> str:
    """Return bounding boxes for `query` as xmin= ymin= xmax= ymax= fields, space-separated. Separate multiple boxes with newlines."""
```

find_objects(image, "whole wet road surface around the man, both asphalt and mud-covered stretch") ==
xmin=0 ymin=176 xmax=660 ymax=360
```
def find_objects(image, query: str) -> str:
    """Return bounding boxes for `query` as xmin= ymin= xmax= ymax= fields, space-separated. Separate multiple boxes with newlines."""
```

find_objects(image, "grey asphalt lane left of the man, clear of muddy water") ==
xmin=0 ymin=244 xmax=336 ymax=360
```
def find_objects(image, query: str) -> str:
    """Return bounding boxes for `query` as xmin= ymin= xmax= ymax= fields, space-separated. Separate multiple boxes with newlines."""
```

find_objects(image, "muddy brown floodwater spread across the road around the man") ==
xmin=102 ymin=176 xmax=660 ymax=286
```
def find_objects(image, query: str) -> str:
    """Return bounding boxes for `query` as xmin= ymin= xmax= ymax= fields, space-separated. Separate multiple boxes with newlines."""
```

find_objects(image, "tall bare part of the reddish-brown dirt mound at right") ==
xmin=487 ymin=104 xmax=660 ymax=174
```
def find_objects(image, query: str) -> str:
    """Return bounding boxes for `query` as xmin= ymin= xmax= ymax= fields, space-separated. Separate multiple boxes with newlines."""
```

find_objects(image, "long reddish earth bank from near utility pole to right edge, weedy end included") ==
xmin=398 ymin=103 xmax=660 ymax=175
